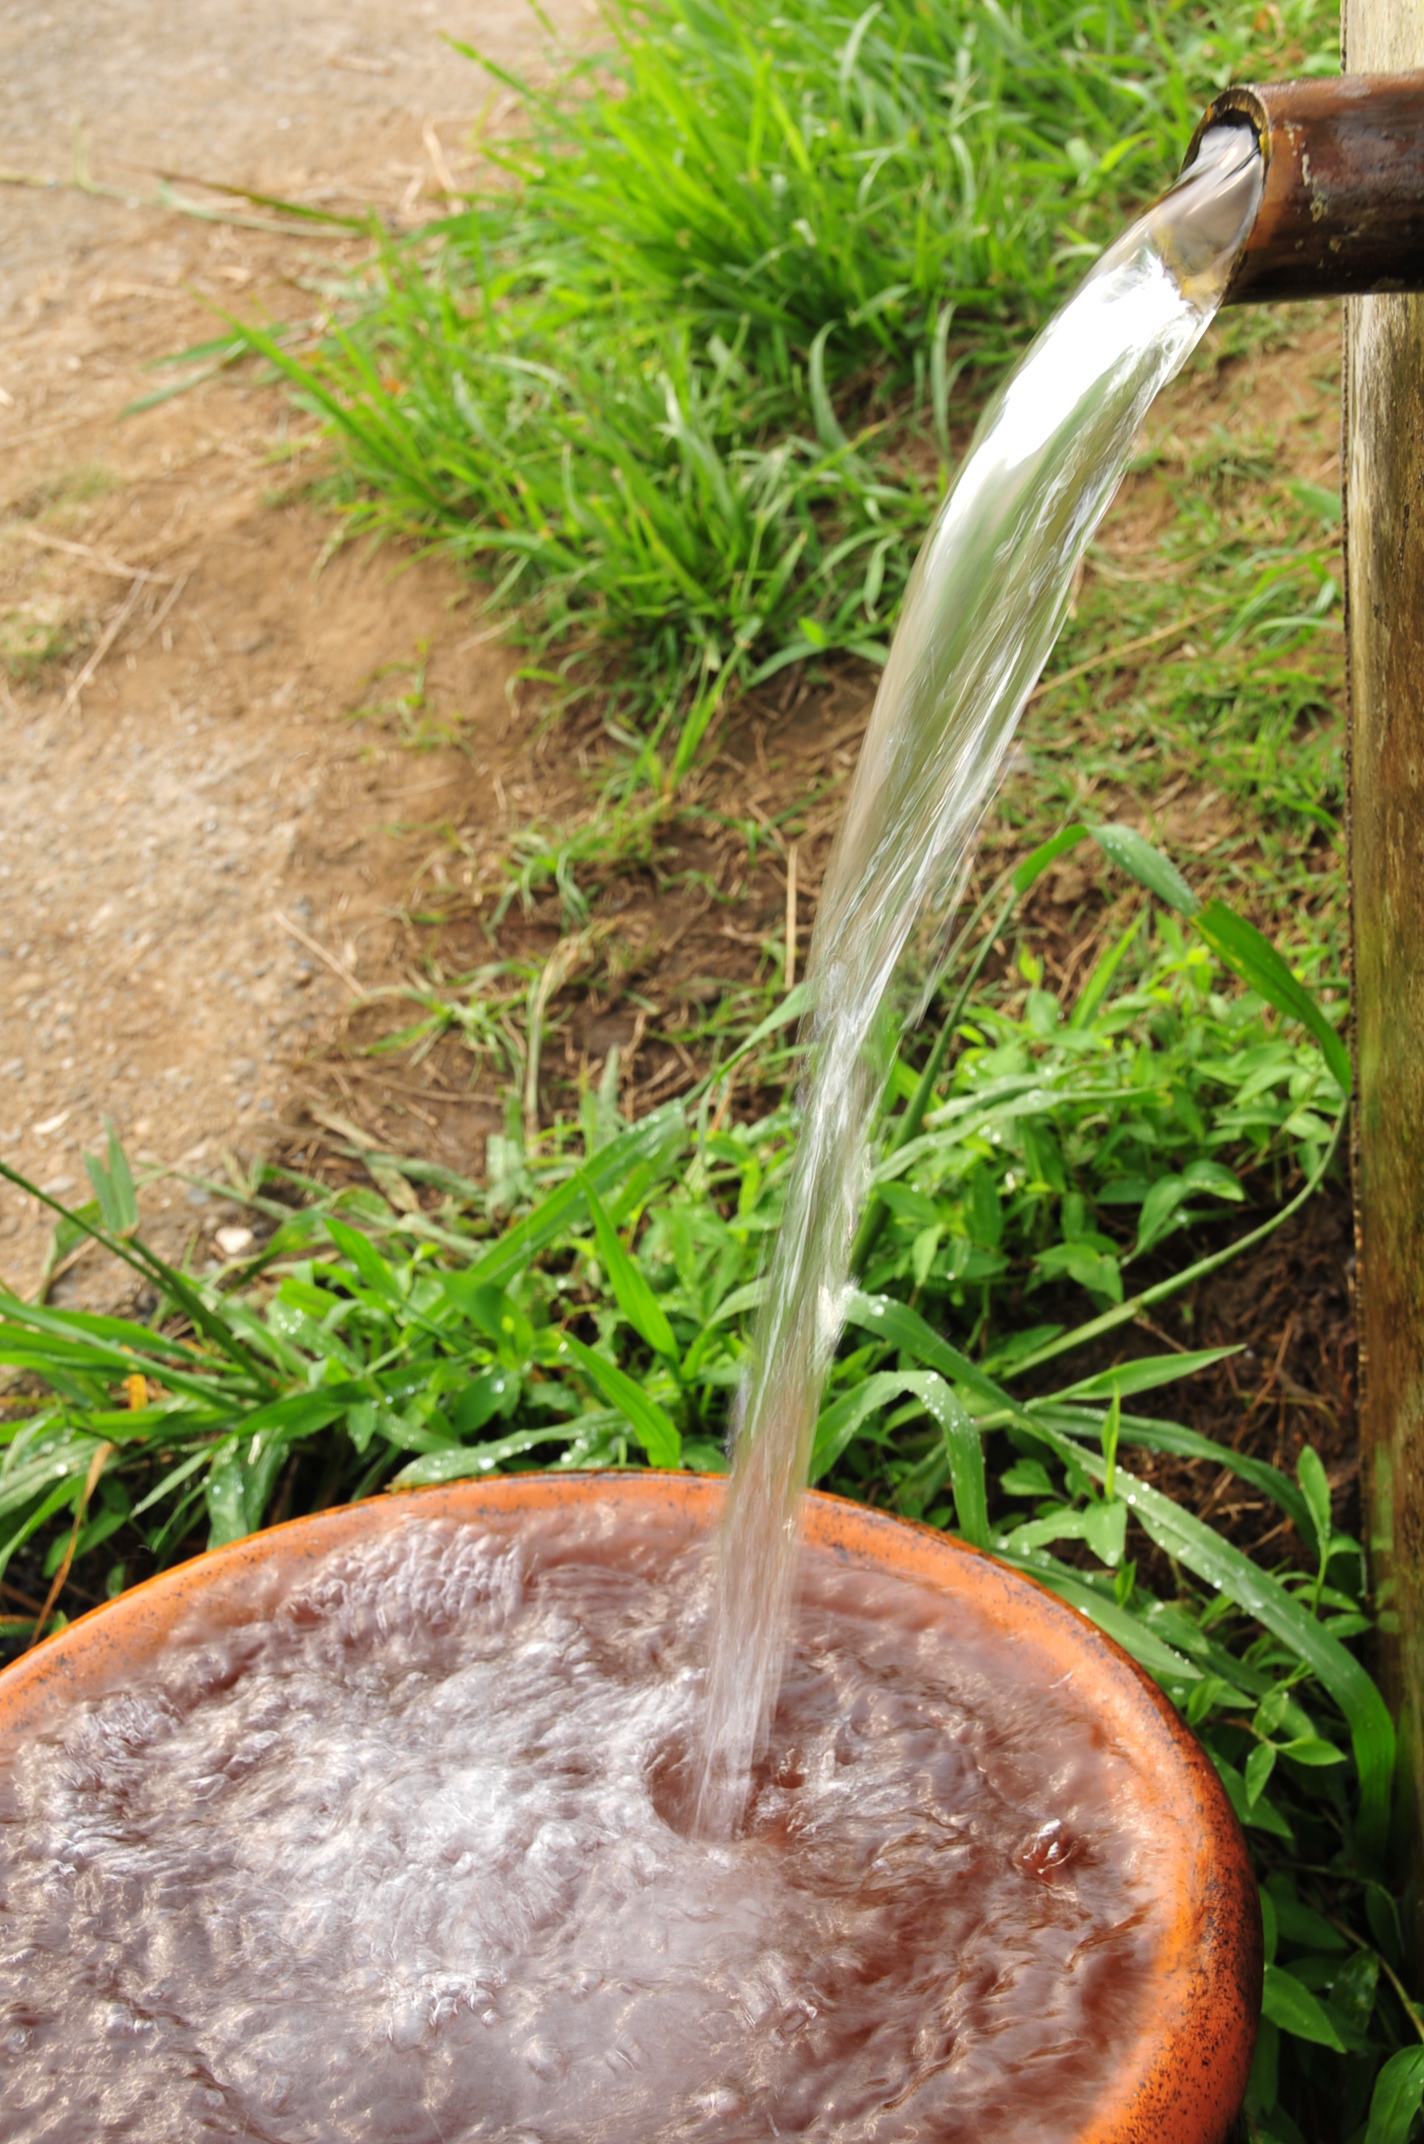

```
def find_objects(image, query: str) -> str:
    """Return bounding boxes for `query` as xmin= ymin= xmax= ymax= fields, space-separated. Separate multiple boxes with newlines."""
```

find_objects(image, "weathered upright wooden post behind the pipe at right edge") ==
xmin=1343 ymin=0 xmax=1424 ymax=1929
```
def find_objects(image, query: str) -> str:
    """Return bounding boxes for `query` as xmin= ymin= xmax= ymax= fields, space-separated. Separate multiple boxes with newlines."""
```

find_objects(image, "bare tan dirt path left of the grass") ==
xmin=0 ymin=0 xmax=585 ymax=1291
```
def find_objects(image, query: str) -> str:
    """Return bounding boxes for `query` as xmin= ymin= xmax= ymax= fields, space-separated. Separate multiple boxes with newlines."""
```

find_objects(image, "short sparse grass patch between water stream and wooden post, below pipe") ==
xmin=1004 ymin=313 xmax=1347 ymax=947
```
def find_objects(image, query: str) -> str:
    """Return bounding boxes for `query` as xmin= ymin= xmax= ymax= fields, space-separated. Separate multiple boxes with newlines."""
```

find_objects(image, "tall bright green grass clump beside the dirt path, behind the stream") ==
xmin=235 ymin=0 xmax=1334 ymax=729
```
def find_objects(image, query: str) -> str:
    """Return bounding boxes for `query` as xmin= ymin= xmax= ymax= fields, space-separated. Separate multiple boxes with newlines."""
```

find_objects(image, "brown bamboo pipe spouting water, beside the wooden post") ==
xmin=1186 ymin=73 xmax=1424 ymax=304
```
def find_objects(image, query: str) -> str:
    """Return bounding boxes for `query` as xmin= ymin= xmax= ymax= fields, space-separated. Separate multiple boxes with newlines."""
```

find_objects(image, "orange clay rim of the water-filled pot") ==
xmin=0 ymin=1473 xmax=1261 ymax=2144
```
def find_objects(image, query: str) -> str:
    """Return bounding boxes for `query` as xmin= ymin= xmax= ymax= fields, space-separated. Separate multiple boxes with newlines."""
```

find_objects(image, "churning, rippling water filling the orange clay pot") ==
xmin=0 ymin=1512 xmax=1165 ymax=2144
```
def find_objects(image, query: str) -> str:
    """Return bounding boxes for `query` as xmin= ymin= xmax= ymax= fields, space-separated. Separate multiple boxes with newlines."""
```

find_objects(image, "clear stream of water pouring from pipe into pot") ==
xmin=695 ymin=126 xmax=1263 ymax=1837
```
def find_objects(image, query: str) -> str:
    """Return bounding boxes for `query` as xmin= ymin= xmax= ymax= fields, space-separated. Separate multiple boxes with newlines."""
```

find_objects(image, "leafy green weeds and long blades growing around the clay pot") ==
xmin=0 ymin=828 xmax=1424 ymax=2144
